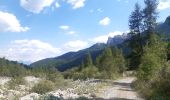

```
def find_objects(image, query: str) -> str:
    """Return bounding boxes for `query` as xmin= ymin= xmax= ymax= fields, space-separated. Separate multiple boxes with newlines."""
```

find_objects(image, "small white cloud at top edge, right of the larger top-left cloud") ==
xmin=67 ymin=0 xmax=85 ymax=9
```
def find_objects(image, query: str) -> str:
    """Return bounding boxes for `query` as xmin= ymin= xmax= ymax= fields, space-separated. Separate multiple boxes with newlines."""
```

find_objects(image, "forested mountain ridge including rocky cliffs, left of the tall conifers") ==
xmin=30 ymin=34 xmax=128 ymax=71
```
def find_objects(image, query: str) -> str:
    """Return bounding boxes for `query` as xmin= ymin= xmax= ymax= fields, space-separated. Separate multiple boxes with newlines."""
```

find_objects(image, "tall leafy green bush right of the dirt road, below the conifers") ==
xmin=138 ymin=34 xmax=167 ymax=81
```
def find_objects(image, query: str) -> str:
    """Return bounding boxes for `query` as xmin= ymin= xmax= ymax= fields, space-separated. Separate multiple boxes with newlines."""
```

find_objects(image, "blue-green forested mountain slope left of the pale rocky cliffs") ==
xmin=30 ymin=43 xmax=107 ymax=71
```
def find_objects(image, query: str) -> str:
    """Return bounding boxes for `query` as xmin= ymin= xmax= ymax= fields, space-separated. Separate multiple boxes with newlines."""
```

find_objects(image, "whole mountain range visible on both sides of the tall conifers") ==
xmin=30 ymin=16 xmax=170 ymax=71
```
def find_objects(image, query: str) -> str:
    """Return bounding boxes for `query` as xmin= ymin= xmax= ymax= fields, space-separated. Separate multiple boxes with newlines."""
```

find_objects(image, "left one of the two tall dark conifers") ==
xmin=129 ymin=3 xmax=144 ymax=69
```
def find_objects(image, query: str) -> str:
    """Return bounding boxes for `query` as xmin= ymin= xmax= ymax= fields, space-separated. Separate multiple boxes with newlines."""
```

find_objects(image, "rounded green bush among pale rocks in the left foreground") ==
xmin=32 ymin=80 xmax=55 ymax=94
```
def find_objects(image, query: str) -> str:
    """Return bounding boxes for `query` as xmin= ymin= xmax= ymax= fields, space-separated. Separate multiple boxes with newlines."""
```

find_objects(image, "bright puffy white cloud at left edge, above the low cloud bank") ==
xmin=0 ymin=11 xmax=29 ymax=32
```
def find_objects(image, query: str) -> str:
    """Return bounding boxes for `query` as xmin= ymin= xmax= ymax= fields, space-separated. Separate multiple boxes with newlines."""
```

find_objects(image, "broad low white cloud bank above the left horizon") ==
xmin=0 ymin=40 xmax=61 ymax=62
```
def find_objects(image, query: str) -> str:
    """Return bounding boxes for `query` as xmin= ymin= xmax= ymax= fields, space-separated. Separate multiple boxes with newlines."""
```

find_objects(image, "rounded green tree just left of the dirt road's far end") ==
xmin=96 ymin=47 xmax=126 ymax=79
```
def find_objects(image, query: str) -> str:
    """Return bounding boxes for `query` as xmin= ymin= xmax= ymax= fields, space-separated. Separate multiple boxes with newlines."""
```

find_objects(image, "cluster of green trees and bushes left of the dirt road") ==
xmin=64 ymin=47 xmax=126 ymax=80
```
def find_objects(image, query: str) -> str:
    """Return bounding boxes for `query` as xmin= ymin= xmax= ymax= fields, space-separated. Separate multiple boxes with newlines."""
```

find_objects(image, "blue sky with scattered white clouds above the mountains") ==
xmin=0 ymin=0 xmax=170 ymax=62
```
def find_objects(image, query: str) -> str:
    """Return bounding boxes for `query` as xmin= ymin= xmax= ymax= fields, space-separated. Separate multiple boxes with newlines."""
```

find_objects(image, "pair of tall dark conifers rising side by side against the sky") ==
xmin=128 ymin=0 xmax=158 ymax=70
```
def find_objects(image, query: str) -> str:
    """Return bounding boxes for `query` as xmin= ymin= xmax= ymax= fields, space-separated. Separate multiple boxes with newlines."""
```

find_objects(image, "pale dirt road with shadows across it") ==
xmin=98 ymin=77 xmax=143 ymax=100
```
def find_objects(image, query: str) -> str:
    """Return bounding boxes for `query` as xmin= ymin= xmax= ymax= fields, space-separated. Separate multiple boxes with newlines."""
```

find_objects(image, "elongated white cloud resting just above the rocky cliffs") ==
xmin=92 ymin=31 xmax=123 ymax=43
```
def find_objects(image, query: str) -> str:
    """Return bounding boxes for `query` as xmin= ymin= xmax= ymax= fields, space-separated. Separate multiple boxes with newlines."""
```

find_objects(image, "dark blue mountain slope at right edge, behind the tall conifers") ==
xmin=156 ymin=16 xmax=170 ymax=35
